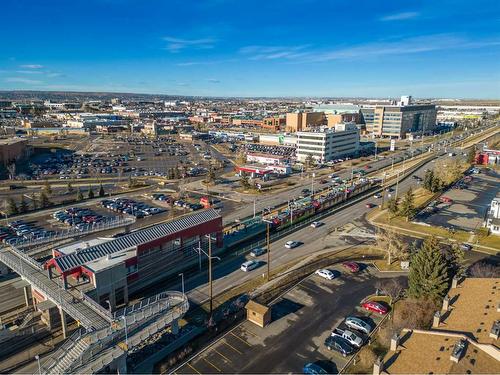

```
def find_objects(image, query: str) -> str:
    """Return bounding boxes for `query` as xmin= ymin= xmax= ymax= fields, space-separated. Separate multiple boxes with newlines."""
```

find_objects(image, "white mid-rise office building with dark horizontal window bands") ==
xmin=297 ymin=123 xmax=359 ymax=162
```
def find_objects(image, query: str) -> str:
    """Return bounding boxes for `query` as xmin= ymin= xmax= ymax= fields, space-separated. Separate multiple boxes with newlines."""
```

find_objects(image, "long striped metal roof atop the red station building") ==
xmin=49 ymin=209 xmax=221 ymax=272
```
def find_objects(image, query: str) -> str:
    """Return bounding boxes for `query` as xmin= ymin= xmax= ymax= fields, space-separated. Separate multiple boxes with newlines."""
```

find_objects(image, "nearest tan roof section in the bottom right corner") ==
xmin=384 ymin=330 xmax=500 ymax=374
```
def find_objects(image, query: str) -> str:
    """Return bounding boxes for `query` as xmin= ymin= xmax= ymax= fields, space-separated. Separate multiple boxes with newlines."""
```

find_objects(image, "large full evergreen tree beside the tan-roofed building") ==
xmin=408 ymin=237 xmax=449 ymax=300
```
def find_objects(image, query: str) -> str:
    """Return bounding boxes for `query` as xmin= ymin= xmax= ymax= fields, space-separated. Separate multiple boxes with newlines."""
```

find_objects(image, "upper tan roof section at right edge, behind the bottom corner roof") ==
xmin=439 ymin=278 xmax=500 ymax=346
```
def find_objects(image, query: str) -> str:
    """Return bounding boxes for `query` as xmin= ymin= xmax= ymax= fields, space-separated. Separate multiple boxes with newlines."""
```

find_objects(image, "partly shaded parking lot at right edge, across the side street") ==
xmin=416 ymin=170 xmax=500 ymax=231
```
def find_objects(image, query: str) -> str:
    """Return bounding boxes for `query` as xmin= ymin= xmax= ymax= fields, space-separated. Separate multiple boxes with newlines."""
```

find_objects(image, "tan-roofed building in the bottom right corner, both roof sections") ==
xmin=373 ymin=278 xmax=500 ymax=375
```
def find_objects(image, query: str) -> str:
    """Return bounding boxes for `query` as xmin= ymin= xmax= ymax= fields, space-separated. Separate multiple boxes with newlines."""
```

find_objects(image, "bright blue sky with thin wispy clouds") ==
xmin=0 ymin=0 xmax=500 ymax=99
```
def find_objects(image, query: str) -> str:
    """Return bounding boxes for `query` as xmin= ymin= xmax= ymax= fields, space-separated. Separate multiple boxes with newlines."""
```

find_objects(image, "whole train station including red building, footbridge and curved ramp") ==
xmin=0 ymin=209 xmax=223 ymax=373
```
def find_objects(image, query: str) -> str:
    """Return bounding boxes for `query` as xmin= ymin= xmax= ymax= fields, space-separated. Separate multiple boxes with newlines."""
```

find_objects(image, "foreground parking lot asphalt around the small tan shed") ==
xmin=176 ymin=266 xmax=394 ymax=374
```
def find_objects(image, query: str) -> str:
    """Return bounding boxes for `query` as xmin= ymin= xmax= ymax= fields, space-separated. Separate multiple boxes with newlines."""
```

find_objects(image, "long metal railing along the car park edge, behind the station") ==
xmin=9 ymin=216 xmax=136 ymax=248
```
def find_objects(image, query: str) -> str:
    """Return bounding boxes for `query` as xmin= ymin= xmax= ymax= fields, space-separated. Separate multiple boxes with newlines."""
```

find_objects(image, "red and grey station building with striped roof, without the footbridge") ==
xmin=45 ymin=209 xmax=223 ymax=309
